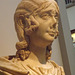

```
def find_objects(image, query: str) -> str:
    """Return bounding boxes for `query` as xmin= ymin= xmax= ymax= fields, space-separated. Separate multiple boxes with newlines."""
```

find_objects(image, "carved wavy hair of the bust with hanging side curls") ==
xmin=14 ymin=0 xmax=59 ymax=60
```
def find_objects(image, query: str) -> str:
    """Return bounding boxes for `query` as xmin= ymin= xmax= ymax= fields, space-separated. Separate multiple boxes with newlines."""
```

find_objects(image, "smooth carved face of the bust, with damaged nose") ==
xmin=31 ymin=3 xmax=59 ymax=47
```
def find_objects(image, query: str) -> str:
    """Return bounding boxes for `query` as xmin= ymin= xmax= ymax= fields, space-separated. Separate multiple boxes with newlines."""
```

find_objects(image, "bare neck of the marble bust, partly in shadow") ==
xmin=29 ymin=44 xmax=46 ymax=64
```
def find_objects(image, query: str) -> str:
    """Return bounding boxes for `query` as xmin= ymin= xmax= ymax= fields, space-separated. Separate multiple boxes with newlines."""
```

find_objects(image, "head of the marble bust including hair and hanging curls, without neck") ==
xmin=14 ymin=0 xmax=59 ymax=60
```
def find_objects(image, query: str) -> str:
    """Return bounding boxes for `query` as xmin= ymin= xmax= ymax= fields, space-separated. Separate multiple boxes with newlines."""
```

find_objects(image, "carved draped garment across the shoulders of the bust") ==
xmin=0 ymin=57 xmax=65 ymax=75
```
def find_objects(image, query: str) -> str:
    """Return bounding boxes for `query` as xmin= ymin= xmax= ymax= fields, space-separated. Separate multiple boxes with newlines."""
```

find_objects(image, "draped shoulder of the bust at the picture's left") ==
xmin=0 ymin=56 xmax=28 ymax=75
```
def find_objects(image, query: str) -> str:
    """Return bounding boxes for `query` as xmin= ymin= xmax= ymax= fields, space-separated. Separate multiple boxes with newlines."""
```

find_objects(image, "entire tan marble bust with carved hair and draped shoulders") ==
xmin=0 ymin=0 xmax=65 ymax=75
